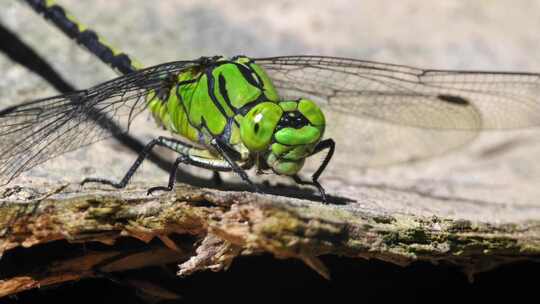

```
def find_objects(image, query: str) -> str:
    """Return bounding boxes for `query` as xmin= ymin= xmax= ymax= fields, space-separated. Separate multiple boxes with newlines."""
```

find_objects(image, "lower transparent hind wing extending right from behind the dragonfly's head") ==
xmin=325 ymin=111 xmax=479 ymax=168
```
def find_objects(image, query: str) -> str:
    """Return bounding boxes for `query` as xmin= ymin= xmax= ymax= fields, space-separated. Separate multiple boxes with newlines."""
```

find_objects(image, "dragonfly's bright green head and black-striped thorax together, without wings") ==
xmin=147 ymin=57 xmax=325 ymax=175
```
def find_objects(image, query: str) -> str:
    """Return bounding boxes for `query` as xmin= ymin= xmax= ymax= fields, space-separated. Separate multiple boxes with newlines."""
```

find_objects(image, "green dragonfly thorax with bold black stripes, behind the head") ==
xmin=147 ymin=56 xmax=279 ymax=145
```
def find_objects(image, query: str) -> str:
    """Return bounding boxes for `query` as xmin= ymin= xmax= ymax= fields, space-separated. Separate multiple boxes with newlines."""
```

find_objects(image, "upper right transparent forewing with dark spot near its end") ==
xmin=256 ymin=56 xmax=540 ymax=130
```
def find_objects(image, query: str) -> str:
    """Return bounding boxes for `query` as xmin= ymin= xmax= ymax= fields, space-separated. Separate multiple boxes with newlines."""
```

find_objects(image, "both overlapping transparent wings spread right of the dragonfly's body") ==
xmin=255 ymin=56 xmax=540 ymax=166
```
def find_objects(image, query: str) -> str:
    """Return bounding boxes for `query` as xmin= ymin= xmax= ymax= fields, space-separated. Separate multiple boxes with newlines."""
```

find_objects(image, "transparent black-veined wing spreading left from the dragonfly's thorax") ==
xmin=0 ymin=61 xmax=199 ymax=184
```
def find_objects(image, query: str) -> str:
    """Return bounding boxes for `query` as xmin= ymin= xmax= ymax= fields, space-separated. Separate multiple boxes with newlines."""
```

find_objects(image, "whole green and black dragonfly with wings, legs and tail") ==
xmin=0 ymin=0 xmax=540 ymax=202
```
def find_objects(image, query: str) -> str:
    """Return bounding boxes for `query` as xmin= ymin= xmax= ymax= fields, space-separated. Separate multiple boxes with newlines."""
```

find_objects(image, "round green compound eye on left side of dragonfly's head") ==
xmin=240 ymin=102 xmax=283 ymax=152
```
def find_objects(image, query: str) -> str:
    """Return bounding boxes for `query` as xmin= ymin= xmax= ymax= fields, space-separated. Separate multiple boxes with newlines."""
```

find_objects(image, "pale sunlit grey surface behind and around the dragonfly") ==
xmin=0 ymin=0 xmax=540 ymax=223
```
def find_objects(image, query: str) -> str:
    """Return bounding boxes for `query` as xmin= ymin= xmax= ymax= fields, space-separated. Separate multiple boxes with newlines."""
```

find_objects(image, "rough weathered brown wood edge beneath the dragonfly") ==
xmin=0 ymin=180 xmax=540 ymax=295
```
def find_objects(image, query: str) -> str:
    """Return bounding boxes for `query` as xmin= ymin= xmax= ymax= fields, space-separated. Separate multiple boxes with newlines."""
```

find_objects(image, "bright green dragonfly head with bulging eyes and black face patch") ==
xmin=240 ymin=99 xmax=325 ymax=175
